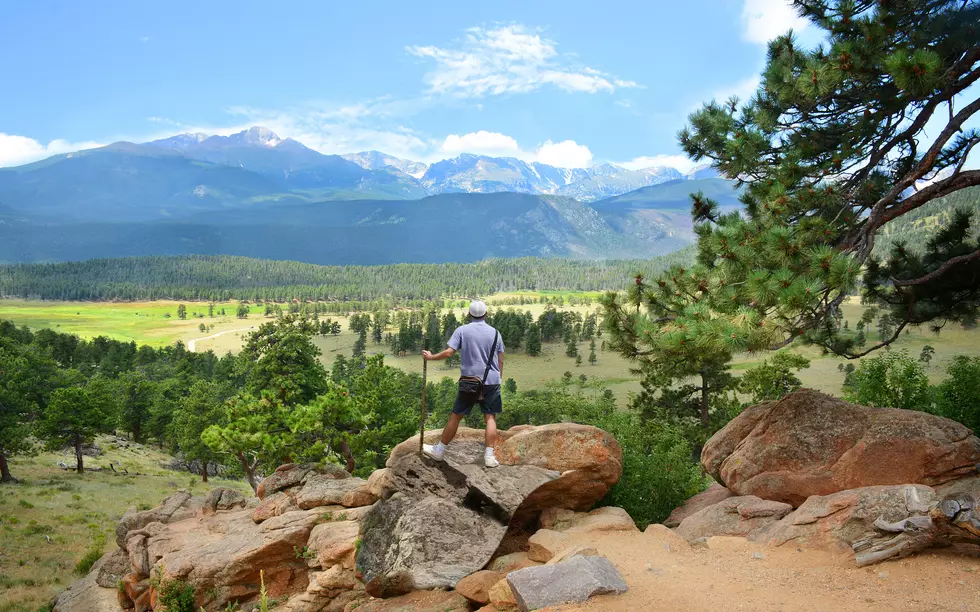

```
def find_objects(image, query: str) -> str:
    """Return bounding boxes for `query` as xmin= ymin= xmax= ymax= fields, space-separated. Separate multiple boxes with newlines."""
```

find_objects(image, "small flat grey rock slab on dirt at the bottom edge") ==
xmin=507 ymin=557 xmax=629 ymax=612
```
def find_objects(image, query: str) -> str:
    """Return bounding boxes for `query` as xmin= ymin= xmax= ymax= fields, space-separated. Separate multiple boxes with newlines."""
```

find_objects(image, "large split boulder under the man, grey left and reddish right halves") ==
xmin=357 ymin=424 xmax=622 ymax=597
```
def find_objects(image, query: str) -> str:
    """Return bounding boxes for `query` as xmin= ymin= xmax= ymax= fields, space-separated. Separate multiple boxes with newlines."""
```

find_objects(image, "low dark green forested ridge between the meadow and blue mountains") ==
xmin=0 ymin=247 xmax=694 ymax=302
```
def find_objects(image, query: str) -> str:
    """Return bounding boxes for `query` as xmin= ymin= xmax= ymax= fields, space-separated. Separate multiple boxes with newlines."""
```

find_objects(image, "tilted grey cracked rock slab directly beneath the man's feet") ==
xmin=357 ymin=440 xmax=559 ymax=597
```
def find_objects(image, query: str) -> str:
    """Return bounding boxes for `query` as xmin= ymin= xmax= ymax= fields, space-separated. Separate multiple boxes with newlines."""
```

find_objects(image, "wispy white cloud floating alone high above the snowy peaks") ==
xmin=407 ymin=24 xmax=636 ymax=97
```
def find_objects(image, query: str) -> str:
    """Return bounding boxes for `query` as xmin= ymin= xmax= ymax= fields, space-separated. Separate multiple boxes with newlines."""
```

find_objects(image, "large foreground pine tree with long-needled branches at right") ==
xmin=606 ymin=0 xmax=980 ymax=364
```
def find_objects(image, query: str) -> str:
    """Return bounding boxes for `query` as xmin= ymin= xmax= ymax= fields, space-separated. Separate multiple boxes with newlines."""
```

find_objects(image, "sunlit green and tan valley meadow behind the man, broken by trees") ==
xmin=0 ymin=292 xmax=980 ymax=404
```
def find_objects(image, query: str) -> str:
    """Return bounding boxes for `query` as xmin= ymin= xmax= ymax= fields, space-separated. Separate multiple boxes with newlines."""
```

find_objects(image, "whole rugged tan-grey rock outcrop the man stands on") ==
xmin=56 ymin=424 xmax=636 ymax=612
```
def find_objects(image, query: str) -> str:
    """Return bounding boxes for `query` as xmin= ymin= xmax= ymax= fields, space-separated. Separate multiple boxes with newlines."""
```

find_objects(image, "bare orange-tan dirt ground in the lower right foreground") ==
xmin=548 ymin=528 xmax=980 ymax=612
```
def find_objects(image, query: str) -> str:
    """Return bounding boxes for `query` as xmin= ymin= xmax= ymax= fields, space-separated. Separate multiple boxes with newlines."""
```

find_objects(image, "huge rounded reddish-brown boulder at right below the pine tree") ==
xmin=701 ymin=389 xmax=980 ymax=507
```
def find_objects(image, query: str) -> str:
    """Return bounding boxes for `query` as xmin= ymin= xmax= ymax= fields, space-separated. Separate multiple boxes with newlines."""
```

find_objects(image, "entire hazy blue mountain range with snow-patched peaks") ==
xmin=0 ymin=127 xmax=738 ymax=264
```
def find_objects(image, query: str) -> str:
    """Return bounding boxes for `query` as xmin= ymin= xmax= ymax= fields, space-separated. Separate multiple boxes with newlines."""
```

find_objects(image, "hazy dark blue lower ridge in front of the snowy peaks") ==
xmin=0 ymin=193 xmax=676 ymax=264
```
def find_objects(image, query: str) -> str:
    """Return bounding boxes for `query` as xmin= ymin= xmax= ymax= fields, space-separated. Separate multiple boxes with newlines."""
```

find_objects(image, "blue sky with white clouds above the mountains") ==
xmin=0 ymin=0 xmax=805 ymax=170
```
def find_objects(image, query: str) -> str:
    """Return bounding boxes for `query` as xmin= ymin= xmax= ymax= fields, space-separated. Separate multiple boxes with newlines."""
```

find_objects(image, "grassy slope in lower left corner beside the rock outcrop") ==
xmin=0 ymin=437 xmax=252 ymax=612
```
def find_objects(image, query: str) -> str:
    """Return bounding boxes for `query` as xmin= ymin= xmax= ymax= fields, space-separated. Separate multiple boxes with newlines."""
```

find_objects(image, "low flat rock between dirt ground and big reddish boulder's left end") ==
xmin=677 ymin=495 xmax=793 ymax=540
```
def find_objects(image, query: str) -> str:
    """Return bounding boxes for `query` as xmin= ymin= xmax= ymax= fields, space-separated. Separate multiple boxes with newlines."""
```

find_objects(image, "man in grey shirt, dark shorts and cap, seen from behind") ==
xmin=422 ymin=300 xmax=504 ymax=467
